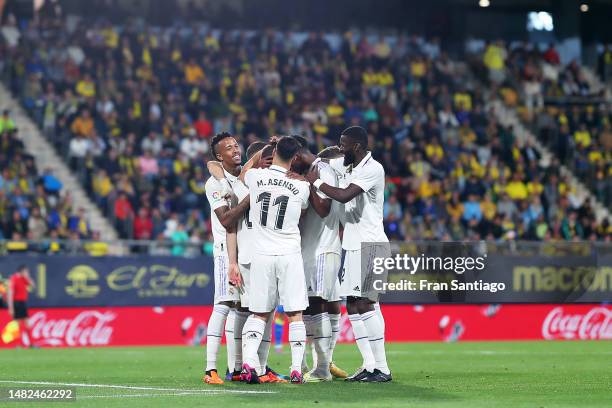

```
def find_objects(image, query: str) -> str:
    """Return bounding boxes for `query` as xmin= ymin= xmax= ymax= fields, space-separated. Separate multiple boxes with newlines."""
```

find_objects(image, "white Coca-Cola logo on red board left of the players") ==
xmin=30 ymin=310 xmax=117 ymax=347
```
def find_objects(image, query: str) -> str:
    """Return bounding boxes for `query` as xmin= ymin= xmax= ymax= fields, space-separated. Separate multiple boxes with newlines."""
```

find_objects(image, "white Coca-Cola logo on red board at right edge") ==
xmin=542 ymin=307 xmax=612 ymax=340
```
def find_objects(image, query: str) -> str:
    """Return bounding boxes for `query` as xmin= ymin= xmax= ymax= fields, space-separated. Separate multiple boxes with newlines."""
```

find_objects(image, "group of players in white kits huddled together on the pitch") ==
xmin=203 ymin=126 xmax=391 ymax=384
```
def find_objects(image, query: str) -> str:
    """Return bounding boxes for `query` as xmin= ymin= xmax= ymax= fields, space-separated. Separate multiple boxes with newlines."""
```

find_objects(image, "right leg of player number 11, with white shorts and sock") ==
xmin=277 ymin=253 xmax=308 ymax=383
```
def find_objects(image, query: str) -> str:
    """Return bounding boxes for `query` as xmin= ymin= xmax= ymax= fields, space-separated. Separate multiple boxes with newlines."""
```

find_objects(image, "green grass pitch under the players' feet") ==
xmin=0 ymin=341 xmax=612 ymax=408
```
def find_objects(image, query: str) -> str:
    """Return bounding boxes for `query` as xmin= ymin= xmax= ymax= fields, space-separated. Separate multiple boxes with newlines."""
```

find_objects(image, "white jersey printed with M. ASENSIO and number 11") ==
xmin=244 ymin=165 xmax=310 ymax=255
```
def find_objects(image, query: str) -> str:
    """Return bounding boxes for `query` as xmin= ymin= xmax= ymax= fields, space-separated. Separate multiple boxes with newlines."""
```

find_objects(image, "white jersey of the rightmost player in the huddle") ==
xmin=330 ymin=152 xmax=389 ymax=250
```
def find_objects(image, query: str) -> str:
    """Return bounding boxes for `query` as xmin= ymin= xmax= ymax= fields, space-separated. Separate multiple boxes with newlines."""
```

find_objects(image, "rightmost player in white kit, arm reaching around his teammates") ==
xmin=306 ymin=126 xmax=391 ymax=382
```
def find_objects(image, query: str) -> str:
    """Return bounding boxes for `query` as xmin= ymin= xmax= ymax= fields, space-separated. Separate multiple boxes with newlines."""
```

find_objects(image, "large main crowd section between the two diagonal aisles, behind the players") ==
xmin=0 ymin=15 xmax=612 ymax=255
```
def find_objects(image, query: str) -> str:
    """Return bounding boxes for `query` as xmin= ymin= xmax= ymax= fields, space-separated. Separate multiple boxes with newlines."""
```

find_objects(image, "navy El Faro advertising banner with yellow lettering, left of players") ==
xmin=0 ymin=256 xmax=214 ymax=307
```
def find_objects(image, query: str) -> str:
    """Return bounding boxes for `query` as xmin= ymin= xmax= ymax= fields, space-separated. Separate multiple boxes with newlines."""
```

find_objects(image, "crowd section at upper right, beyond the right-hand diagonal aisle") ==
xmin=477 ymin=42 xmax=612 ymax=208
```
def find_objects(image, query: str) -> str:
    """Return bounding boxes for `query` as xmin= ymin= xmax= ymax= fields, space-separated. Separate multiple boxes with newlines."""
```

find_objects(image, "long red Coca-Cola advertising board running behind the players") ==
xmin=0 ymin=304 xmax=612 ymax=347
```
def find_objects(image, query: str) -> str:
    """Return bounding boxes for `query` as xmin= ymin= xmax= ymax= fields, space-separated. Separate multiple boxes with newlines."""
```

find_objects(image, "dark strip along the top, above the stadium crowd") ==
xmin=6 ymin=0 xmax=612 ymax=43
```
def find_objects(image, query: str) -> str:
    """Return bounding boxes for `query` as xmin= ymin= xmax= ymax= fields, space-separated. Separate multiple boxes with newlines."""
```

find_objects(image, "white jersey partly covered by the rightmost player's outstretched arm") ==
xmin=302 ymin=162 xmax=342 ymax=261
